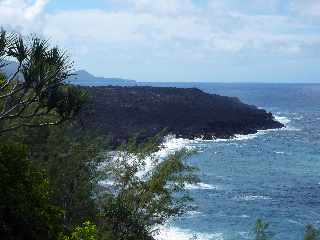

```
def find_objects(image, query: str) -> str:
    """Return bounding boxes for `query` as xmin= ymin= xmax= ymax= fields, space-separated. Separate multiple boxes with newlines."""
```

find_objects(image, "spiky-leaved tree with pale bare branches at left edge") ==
xmin=0 ymin=30 xmax=85 ymax=135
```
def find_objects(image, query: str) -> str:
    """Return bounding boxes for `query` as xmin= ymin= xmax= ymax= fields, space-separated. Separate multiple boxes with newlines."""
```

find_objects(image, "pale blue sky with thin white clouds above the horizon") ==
xmin=0 ymin=0 xmax=320 ymax=83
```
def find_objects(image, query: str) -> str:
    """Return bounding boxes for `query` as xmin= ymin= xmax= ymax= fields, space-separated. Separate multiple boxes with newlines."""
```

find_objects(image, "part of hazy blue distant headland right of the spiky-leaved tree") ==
xmin=69 ymin=70 xmax=137 ymax=86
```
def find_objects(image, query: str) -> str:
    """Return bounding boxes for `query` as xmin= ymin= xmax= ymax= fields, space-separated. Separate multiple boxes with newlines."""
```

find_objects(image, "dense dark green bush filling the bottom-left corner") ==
xmin=0 ymin=144 xmax=62 ymax=239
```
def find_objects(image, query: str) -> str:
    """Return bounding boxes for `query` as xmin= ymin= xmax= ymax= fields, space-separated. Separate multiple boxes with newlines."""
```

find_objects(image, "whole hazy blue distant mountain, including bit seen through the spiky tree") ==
xmin=1 ymin=61 xmax=137 ymax=86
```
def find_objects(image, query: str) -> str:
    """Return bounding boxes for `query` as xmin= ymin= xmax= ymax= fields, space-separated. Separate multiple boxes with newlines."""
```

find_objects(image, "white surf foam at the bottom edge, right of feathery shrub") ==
xmin=154 ymin=226 xmax=223 ymax=240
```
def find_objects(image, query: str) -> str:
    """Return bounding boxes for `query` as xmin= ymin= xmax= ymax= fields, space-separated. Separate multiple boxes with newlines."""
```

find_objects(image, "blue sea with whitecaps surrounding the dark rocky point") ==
xmin=139 ymin=83 xmax=320 ymax=240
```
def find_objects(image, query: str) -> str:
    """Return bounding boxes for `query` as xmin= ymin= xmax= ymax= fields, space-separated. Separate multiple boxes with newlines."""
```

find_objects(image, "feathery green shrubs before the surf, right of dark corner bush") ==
xmin=7 ymin=123 xmax=197 ymax=239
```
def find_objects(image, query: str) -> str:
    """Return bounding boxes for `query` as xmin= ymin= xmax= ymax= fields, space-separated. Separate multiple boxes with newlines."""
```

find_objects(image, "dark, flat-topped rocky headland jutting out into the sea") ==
xmin=79 ymin=87 xmax=283 ymax=144
